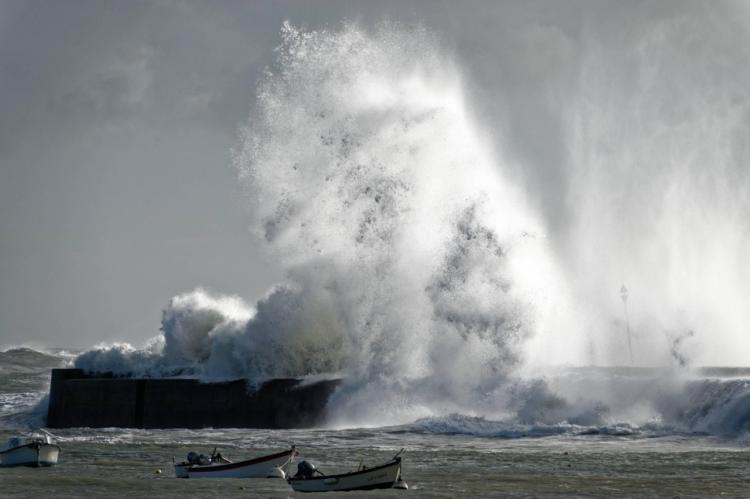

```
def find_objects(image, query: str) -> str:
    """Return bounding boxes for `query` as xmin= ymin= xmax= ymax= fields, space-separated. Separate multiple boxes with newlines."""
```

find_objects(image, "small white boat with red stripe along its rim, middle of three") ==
xmin=174 ymin=446 xmax=297 ymax=478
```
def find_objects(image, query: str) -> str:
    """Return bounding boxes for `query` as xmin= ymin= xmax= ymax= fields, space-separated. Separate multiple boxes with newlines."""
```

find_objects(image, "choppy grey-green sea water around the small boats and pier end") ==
xmin=0 ymin=349 xmax=750 ymax=497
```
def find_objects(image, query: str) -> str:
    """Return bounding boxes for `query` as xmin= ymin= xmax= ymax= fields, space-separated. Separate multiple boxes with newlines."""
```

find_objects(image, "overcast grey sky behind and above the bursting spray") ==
xmin=0 ymin=0 xmax=747 ymax=347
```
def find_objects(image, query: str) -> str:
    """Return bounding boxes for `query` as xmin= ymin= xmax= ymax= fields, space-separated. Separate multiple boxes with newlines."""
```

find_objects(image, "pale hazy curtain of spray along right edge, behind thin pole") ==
xmin=556 ymin=2 xmax=750 ymax=365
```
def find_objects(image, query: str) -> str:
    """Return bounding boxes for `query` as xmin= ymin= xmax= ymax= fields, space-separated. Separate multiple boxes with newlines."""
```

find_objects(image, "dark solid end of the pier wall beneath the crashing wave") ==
xmin=47 ymin=369 xmax=341 ymax=428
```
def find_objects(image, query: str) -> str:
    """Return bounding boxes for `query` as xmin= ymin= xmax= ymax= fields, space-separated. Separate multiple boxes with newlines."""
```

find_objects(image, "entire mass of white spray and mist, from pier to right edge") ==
xmin=76 ymin=8 xmax=750 ymax=434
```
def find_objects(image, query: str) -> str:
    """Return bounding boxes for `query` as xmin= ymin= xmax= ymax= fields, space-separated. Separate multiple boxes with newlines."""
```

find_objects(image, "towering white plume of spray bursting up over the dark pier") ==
xmin=77 ymin=24 xmax=560 ymax=423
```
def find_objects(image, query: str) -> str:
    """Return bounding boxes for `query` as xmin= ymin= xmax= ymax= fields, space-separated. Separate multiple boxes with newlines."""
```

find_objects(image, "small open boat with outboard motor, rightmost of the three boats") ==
xmin=287 ymin=449 xmax=407 ymax=492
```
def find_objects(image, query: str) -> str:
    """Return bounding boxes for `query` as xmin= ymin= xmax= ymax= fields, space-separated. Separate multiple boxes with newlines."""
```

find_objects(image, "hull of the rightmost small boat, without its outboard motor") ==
xmin=288 ymin=458 xmax=401 ymax=492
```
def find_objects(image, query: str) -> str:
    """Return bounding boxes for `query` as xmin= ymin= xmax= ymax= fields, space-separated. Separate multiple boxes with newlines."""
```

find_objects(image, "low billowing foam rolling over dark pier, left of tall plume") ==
xmin=74 ymin=286 xmax=340 ymax=380
